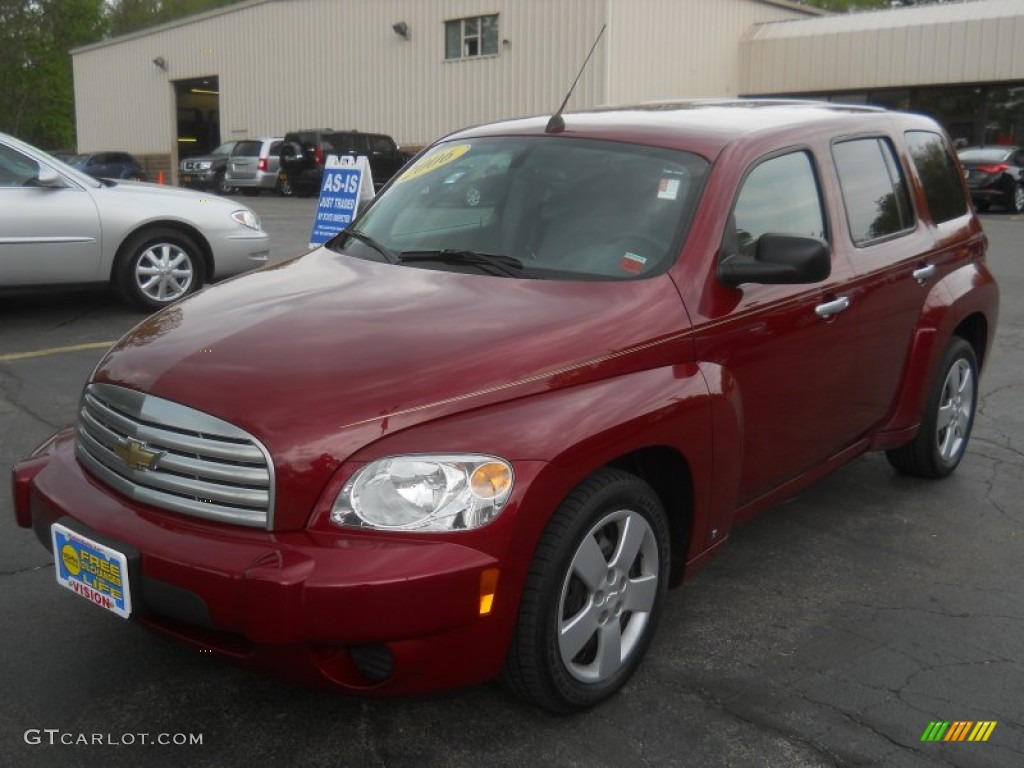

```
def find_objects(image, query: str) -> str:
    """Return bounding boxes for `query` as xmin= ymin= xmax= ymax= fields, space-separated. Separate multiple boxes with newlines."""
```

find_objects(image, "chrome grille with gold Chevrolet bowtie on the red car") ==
xmin=76 ymin=384 xmax=273 ymax=528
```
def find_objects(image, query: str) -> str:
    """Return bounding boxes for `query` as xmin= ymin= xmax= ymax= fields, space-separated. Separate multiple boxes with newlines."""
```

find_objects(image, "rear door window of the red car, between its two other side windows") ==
xmin=833 ymin=137 xmax=913 ymax=246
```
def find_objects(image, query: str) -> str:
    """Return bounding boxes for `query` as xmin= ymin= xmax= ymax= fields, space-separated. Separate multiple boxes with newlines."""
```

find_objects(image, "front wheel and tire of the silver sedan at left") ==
xmin=115 ymin=229 xmax=206 ymax=311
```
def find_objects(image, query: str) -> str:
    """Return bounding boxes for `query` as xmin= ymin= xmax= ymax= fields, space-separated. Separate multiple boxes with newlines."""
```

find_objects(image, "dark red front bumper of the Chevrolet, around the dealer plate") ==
xmin=13 ymin=430 xmax=514 ymax=694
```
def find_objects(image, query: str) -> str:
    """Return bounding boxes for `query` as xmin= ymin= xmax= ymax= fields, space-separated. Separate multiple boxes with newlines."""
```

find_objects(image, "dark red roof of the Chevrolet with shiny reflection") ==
xmin=446 ymin=99 xmax=938 ymax=159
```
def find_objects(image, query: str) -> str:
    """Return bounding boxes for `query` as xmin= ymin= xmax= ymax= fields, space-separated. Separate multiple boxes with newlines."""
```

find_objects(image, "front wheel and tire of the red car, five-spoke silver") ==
xmin=503 ymin=469 xmax=670 ymax=712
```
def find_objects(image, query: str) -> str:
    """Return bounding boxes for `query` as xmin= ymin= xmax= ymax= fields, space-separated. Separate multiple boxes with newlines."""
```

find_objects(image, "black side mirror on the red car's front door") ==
xmin=718 ymin=232 xmax=831 ymax=288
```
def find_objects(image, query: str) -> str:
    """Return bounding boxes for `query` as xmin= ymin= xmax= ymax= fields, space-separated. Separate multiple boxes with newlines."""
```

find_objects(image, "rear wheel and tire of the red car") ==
xmin=886 ymin=337 xmax=978 ymax=478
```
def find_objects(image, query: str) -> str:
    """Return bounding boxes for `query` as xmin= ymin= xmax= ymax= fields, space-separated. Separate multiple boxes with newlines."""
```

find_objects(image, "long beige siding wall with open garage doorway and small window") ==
xmin=74 ymin=0 xmax=607 ymax=153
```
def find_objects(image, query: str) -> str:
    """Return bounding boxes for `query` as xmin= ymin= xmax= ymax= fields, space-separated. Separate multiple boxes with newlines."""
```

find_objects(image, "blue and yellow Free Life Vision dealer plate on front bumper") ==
xmin=50 ymin=522 xmax=131 ymax=618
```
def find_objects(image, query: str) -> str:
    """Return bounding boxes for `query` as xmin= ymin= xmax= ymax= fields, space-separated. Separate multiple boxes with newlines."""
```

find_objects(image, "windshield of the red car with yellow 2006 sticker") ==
xmin=339 ymin=136 xmax=709 ymax=280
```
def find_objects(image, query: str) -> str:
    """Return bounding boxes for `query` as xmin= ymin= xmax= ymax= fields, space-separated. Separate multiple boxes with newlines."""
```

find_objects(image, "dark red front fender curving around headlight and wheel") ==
xmin=314 ymin=364 xmax=713 ymax=651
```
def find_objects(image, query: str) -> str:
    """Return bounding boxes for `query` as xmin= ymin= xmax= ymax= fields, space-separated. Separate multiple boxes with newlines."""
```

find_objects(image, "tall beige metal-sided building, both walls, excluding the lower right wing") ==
xmin=72 ymin=0 xmax=817 ymax=179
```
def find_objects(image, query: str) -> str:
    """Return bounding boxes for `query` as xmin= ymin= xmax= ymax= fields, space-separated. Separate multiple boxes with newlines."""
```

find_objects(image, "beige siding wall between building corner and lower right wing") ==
xmin=608 ymin=0 xmax=807 ymax=103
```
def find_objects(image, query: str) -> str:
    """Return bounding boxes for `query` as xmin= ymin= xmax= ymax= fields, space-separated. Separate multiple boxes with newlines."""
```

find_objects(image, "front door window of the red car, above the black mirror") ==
xmin=728 ymin=152 xmax=825 ymax=256
